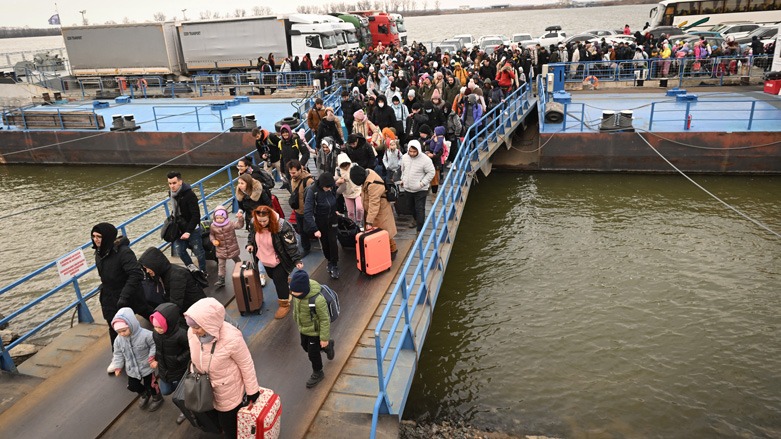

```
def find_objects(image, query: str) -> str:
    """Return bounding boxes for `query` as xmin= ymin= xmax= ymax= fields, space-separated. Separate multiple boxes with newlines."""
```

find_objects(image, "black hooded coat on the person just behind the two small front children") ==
xmin=138 ymin=247 xmax=206 ymax=316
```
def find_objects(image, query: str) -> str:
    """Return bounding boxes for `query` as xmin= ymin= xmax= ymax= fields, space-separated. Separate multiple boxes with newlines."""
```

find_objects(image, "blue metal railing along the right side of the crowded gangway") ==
xmin=371 ymin=84 xmax=536 ymax=438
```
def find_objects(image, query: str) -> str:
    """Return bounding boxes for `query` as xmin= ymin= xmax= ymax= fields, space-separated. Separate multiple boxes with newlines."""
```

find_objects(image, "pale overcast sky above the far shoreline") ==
xmin=0 ymin=0 xmax=552 ymax=27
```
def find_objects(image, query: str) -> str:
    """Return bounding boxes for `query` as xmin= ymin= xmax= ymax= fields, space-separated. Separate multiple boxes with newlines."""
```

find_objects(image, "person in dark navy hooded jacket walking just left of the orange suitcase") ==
xmin=304 ymin=172 xmax=339 ymax=279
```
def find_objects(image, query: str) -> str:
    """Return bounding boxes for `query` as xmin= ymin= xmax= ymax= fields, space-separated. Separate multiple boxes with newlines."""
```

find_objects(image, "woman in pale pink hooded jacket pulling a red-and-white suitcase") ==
xmin=184 ymin=297 xmax=260 ymax=438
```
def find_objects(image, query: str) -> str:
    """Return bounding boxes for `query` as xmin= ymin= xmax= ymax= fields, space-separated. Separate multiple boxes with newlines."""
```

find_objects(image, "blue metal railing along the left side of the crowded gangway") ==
xmin=0 ymin=84 xmax=341 ymax=371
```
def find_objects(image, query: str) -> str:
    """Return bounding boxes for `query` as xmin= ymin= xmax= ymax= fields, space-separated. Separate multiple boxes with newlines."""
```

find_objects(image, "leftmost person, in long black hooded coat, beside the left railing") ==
xmin=90 ymin=223 xmax=152 ymax=362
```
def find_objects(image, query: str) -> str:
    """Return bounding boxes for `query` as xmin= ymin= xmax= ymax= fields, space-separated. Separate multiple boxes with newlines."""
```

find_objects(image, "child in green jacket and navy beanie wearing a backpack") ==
xmin=290 ymin=270 xmax=334 ymax=389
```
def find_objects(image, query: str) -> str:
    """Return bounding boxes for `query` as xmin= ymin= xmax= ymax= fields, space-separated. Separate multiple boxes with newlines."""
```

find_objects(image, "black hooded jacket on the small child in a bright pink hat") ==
xmin=152 ymin=303 xmax=190 ymax=383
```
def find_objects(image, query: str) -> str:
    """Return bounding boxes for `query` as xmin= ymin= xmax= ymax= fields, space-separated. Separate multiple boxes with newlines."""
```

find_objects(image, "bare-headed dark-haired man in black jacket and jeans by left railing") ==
xmin=168 ymin=172 xmax=206 ymax=272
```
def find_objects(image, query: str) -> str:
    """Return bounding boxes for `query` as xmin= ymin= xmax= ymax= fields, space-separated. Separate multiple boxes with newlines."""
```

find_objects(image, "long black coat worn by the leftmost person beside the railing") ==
xmin=95 ymin=236 xmax=151 ymax=321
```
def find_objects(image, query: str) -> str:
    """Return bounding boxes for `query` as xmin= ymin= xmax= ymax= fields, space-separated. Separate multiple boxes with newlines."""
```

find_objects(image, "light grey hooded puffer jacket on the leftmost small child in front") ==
xmin=111 ymin=307 xmax=155 ymax=380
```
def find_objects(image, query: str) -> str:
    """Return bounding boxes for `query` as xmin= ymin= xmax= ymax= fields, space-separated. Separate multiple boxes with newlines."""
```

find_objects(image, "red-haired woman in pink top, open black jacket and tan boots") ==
xmin=246 ymin=206 xmax=304 ymax=319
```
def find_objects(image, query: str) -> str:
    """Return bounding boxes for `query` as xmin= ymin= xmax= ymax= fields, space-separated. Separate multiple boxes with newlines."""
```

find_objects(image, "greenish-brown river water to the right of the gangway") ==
xmin=404 ymin=173 xmax=781 ymax=438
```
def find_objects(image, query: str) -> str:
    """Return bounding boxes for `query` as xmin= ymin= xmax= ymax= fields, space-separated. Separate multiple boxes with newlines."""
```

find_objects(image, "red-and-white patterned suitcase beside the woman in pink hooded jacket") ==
xmin=236 ymin=387 xmax=282 ymax=439
